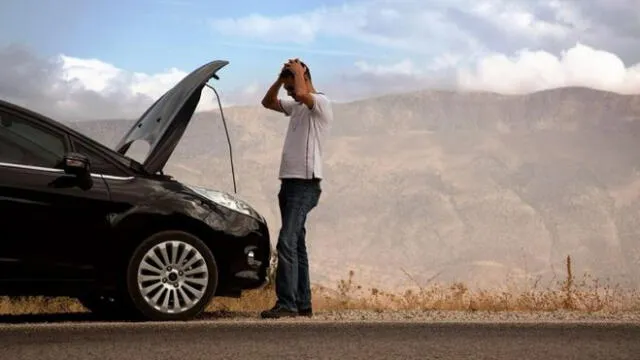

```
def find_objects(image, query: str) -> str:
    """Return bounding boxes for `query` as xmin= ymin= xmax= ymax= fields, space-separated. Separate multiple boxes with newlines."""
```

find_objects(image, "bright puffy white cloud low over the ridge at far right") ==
xmin=457 ymin=43 xmax=640 ymax=94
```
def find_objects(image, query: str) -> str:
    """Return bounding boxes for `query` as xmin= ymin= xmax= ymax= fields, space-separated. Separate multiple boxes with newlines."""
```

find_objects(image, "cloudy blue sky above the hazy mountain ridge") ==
xmin=0 ymin=0 xmax=640 ymax=120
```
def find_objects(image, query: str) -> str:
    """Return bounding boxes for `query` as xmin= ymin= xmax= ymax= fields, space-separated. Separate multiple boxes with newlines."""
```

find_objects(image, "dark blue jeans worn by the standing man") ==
xmin=276 ymin=179 xmax=322 ymax=311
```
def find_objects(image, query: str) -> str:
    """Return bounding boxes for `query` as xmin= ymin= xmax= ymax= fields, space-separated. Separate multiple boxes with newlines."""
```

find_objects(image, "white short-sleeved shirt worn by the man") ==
xmin=279 ymin=93 xmax=333 ymax=179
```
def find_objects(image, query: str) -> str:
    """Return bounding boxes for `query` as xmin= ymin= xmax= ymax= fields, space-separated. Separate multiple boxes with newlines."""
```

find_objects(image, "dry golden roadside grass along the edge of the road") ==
xmin=0 ymin=253 xmax=640 ymax=314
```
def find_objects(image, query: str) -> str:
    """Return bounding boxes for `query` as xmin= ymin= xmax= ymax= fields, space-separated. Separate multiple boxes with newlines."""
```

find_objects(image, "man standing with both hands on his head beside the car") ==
xmin=261 ymin=59 xmax=333 ymax=318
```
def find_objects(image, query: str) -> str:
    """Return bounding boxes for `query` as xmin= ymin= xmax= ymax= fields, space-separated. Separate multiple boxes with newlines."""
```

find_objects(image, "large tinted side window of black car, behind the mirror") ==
xmin=0 ymin=110 xmax=66 ymax=168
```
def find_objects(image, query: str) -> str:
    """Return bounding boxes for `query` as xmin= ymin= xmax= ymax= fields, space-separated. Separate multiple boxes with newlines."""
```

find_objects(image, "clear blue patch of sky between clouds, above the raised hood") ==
xmin=0 ymin=0 xmax=375 ymax=88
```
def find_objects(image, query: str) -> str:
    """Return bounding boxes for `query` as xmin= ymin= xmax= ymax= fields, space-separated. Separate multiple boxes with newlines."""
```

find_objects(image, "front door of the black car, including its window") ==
xmin=0 ymin=108 xmax=109 ymax=281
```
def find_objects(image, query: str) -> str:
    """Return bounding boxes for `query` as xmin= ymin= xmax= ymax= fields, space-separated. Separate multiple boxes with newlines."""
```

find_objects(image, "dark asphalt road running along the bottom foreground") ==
xmin=0 ymin=320 xmax=640 ymax=360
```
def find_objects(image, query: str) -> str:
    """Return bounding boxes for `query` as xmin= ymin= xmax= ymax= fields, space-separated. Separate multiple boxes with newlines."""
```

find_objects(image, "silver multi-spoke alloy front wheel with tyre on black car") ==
xmin=127 ymin=231 xmax=218 ymax=320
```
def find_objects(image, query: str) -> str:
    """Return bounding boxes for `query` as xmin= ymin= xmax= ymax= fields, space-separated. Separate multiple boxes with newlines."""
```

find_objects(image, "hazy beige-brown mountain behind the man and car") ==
xmin=63 ymin=88 xmax=640 ymax=288
